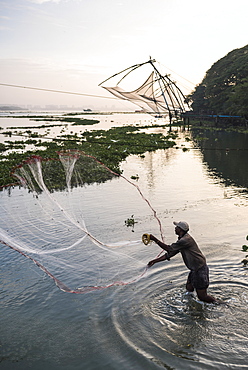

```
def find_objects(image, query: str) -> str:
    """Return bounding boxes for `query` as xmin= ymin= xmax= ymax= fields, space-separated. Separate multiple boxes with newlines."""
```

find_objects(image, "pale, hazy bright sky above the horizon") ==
xmin=0 ymin=0 xmax=248 ymax=109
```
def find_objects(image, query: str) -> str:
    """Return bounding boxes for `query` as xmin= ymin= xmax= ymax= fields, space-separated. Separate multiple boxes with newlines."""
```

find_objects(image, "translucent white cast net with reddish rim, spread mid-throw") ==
xmin=0 ymin=151 xmax=164 ymax=293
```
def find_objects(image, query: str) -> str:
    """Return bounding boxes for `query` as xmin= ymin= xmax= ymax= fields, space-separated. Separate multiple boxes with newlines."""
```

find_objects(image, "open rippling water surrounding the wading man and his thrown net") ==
xmin=0 ymin=117 xmax=248 ymax=370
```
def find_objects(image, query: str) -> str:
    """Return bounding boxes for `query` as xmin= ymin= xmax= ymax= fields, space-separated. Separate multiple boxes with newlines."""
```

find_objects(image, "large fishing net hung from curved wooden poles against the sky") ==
xmin=99 ymin=58 xmax=188 ymax=122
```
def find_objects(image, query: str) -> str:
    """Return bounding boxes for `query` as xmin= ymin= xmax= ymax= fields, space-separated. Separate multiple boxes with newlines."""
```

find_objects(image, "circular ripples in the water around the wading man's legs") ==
xmin=109 ymin=270 xmax=248 ymax=369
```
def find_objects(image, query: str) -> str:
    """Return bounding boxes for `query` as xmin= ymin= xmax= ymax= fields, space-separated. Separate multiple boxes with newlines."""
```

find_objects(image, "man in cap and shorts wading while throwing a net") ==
xmin=148 ymin=221 xmax=217 ymax=303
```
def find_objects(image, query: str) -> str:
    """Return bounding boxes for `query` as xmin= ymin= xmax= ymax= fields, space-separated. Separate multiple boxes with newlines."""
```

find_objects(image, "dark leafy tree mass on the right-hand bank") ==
xmin=188 ymin=45 xmax=248 ymax=117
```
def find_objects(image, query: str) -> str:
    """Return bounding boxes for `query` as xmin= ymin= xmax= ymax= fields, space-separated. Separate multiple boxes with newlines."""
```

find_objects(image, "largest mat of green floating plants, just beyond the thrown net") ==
xmin=0 ymin=126 xmax=178 ymax=186
